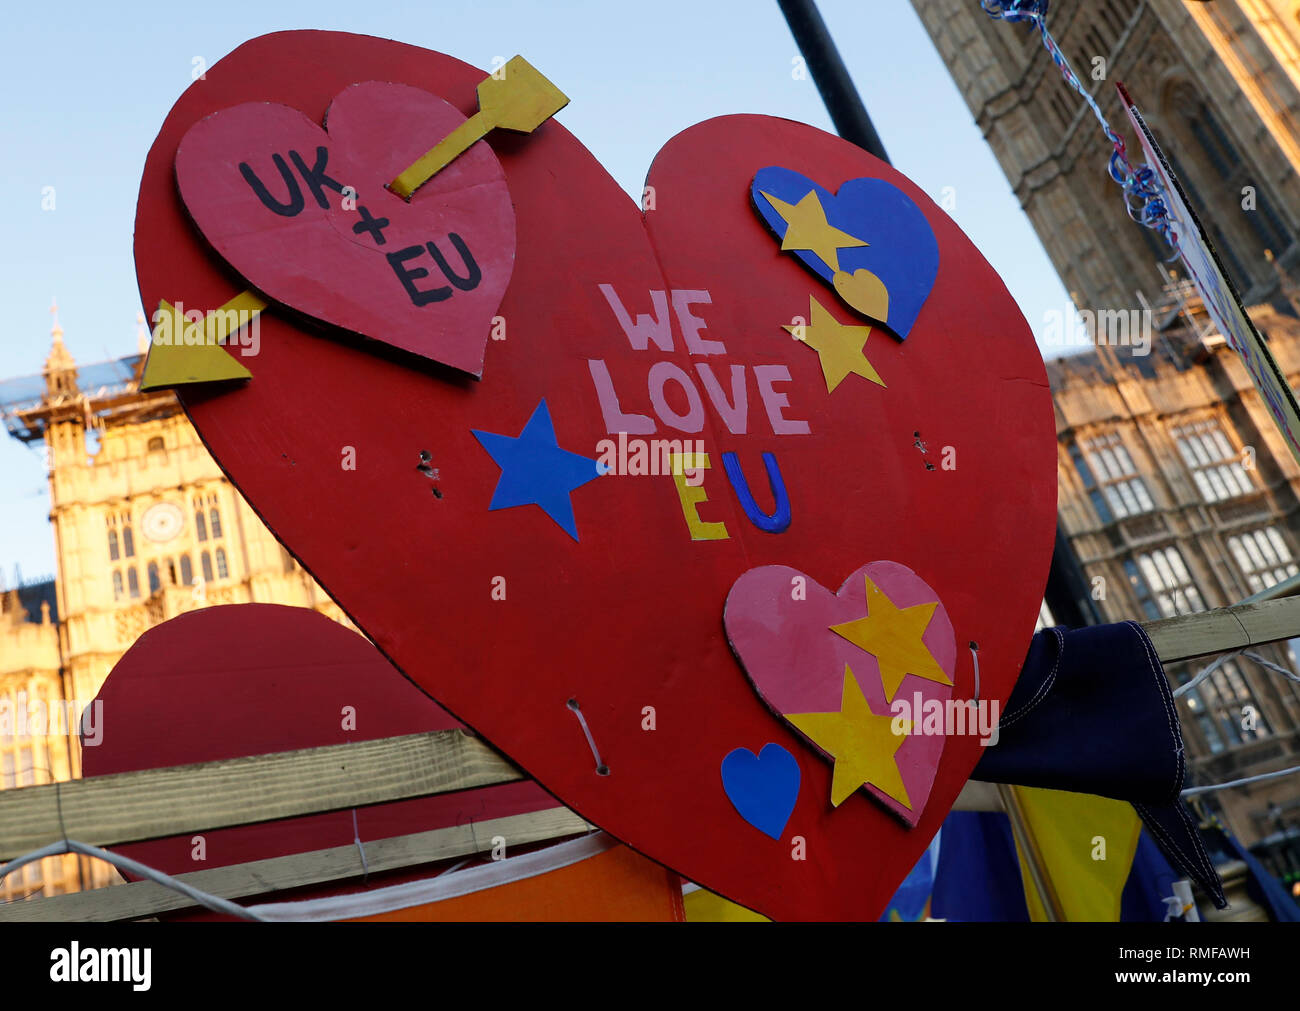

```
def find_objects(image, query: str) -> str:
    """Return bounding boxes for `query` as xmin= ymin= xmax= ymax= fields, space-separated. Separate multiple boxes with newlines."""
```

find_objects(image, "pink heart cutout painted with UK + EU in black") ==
xmin=176 ymin=81 xmax=515 ymax=376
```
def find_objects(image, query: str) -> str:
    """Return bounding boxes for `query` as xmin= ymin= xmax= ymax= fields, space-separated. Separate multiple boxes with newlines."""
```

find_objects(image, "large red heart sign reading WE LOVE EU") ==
xmin=135 ymin=32 xmax=1056 ymax=919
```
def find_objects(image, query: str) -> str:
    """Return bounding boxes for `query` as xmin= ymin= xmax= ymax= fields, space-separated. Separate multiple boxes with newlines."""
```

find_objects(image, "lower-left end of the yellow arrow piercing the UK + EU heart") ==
xmin=140 ymin=291 xmax=267 ymax=392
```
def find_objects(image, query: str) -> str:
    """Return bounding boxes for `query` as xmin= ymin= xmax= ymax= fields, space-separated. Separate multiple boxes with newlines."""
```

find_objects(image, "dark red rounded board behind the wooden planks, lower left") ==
xmin=82 ymin=604 xmax=556 ymax=919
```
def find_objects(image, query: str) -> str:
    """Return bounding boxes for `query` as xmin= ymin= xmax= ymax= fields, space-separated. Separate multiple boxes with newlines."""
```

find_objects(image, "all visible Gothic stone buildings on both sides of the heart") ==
xmin=0 ymin=0 xmax=1300 ymax=901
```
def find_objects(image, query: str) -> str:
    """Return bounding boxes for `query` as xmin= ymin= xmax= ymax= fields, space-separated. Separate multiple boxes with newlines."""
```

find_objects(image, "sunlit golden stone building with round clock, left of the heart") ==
xmin=0 ymin=316 xmax=351 ymax=901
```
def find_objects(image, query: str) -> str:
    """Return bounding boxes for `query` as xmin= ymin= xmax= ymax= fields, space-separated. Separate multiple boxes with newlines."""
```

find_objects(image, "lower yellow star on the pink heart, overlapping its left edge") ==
xmin=785 ymin=664 xmax=915 ymax=811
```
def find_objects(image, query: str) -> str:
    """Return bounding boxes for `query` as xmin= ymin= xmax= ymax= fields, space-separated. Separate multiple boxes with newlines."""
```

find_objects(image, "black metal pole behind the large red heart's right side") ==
xmin=776 ymin=0 xmax=1102 ymax=626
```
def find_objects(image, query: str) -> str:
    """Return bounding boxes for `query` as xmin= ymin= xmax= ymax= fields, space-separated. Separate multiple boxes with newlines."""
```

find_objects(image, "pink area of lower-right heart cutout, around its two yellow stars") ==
xmin=723 ymin=561 xmax=957 ymax=825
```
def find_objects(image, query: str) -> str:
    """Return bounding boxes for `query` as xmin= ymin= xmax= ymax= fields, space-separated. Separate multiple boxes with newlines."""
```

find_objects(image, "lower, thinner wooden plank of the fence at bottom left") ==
xmin=0 ymin=807 xmax=595 ymax=923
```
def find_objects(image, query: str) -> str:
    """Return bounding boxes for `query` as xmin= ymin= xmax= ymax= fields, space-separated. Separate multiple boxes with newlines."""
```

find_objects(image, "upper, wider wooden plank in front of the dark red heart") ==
xmin=0 ymin=730 xmax=524 ymax=860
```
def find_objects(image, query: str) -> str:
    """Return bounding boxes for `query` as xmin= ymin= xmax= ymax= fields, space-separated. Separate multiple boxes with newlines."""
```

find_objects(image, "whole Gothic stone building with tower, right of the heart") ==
xmin=913 ymin=0 xmax=1300 ymax=878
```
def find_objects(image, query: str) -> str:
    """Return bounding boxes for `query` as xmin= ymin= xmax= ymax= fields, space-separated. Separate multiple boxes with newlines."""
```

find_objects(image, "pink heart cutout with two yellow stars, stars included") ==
xmin=724 ymin=561 xmax=957 ymax=825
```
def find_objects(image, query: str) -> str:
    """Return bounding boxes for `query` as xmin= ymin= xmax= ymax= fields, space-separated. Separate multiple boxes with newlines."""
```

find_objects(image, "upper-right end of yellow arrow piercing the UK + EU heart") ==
xmin=389 ymin=56 xmax=568 ymax=200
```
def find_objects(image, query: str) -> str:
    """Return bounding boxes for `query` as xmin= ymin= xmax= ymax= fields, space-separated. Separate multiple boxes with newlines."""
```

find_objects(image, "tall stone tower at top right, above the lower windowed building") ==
xmin=913 ymin=0 xmax=1300 ymax=310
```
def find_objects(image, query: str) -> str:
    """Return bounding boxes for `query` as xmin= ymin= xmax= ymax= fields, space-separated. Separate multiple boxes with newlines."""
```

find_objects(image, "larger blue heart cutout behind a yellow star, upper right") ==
xmin=749 ymin=165 xmax=939 ymax=339
